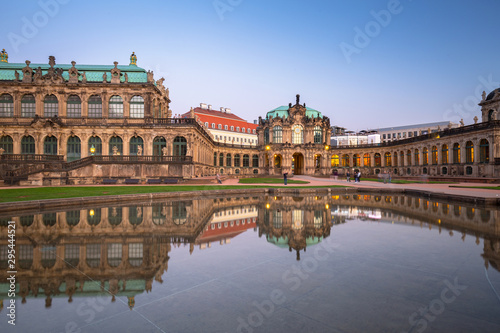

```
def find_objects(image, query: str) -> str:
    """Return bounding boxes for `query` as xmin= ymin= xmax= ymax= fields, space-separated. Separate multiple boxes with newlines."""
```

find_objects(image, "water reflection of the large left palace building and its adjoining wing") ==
xmin=0 ymin=198 xmax=256 ymax=309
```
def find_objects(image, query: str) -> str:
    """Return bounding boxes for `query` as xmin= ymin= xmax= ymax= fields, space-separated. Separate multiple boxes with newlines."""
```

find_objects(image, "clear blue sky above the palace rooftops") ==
xmin=0 ymin=0 xmax=500 ymax=130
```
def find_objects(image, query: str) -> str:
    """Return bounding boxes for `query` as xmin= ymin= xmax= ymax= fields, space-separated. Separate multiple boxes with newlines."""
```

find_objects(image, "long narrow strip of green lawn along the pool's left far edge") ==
xmin=0 ymin=185 xmax=345 ymax=202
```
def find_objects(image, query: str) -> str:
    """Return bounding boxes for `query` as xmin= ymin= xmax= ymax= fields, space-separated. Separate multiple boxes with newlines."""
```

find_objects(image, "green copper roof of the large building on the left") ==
xmin=0 ymin=62 xmax=148 ymax=83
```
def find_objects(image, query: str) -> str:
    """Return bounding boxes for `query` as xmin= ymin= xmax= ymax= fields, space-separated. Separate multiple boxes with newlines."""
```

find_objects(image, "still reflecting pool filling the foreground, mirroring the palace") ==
xmin=0 ymin=194 xmax=500 ymax=333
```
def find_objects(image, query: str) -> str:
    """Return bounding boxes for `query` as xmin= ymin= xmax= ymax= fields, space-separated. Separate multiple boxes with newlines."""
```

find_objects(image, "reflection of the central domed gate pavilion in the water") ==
xmin=258 ymin=196 xmax=332 ymax=260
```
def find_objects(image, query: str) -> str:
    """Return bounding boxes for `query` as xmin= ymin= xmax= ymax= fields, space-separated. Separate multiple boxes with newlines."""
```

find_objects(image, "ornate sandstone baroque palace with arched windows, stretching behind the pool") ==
xmin=0 ymin=50 xmax=500 ymax=185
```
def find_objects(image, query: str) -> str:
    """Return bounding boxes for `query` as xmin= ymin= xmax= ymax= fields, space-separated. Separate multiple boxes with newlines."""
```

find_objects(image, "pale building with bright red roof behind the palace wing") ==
xmin=182 ymin=103 xmax=258 ymax=146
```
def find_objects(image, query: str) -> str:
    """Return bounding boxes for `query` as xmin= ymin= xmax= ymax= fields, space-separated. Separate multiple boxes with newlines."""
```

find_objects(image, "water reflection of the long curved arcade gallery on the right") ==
xmin=330 ymin=194 xmax=500 ymax=271
